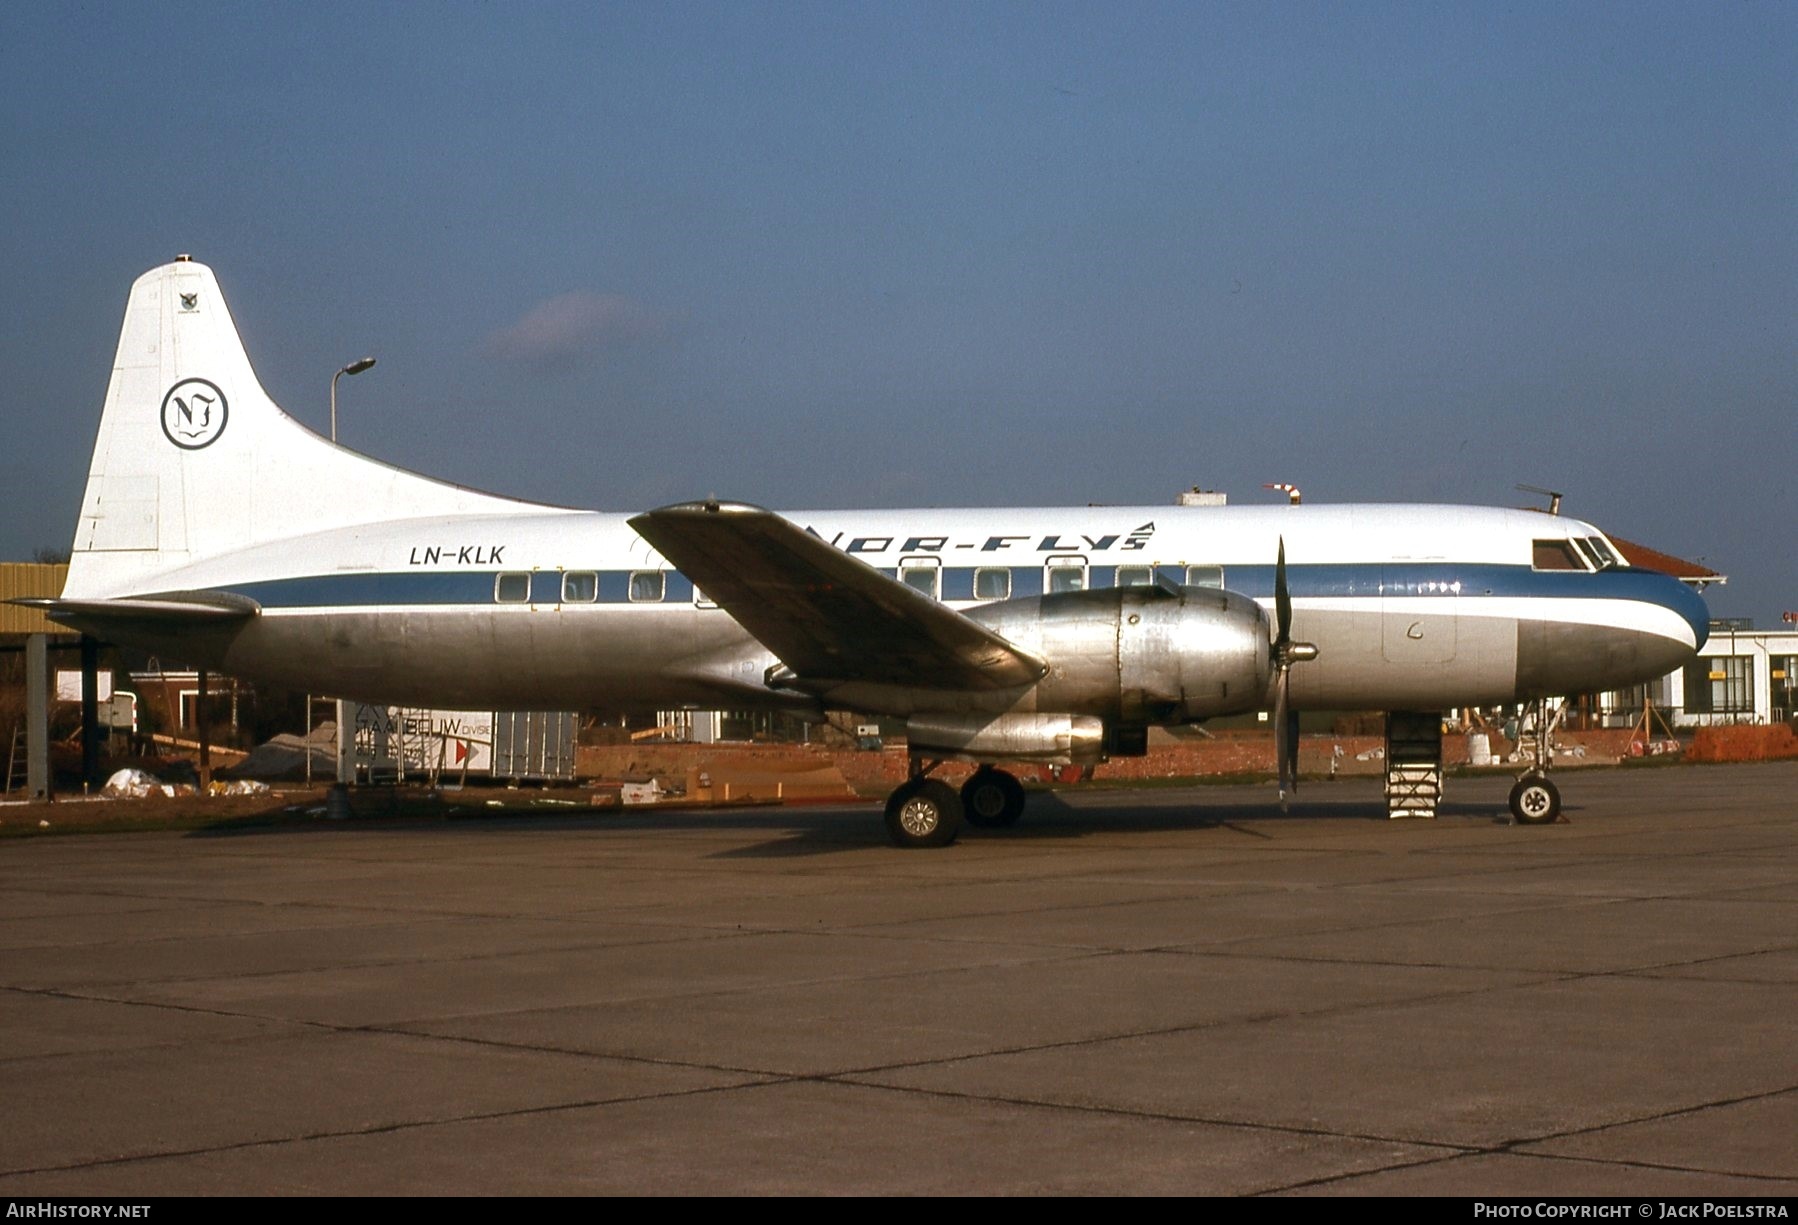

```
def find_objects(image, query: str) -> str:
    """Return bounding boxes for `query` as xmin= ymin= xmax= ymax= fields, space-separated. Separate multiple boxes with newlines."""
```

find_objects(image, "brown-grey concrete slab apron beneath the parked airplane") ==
xmin=0 ymin=763 xmax=1798 ymax=1202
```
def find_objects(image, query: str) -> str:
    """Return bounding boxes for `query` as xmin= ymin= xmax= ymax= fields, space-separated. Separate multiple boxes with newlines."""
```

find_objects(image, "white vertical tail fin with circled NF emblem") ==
xmin=63 ymin=255 xmax=539 ymax=597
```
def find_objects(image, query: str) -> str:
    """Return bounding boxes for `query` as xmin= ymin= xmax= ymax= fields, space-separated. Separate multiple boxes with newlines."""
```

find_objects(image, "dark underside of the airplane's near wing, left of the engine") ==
xmin=631 ymin=502 xmax=1045 ymax=689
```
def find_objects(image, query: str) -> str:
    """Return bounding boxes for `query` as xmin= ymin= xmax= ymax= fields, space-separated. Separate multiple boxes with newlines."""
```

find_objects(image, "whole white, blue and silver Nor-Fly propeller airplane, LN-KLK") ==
xmin=24 ymin=255 xmax=1708 ymax=847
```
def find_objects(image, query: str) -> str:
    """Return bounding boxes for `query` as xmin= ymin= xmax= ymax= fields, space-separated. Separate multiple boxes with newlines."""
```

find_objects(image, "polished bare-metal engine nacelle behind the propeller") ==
xmin=967 ymin=586 xmax=1273 ymax=725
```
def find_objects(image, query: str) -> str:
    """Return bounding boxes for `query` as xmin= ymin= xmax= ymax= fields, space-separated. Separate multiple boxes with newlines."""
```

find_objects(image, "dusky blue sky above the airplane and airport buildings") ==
xmin=0 ymin=0 xmax=1798 ymax=622
